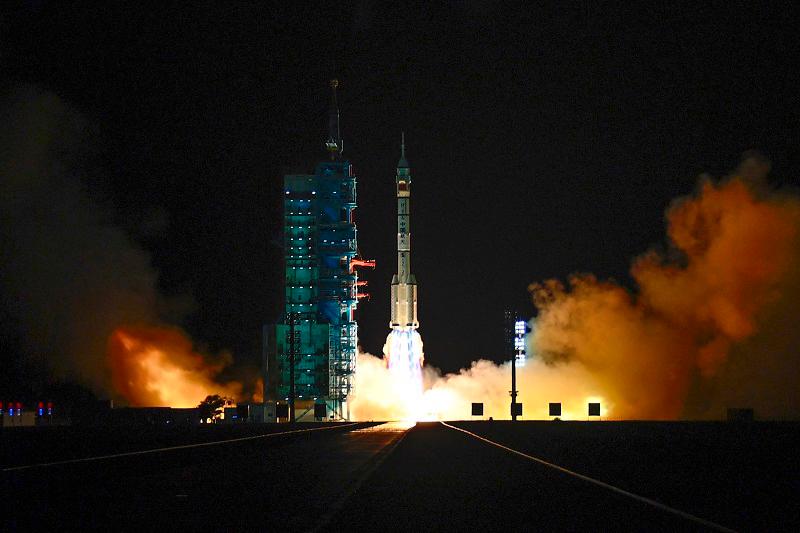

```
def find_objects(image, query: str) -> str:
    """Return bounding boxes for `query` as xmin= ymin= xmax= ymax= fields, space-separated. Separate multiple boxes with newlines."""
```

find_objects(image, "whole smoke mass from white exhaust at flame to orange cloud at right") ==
xmin=353 ymin=154 xmax=800 ymax=419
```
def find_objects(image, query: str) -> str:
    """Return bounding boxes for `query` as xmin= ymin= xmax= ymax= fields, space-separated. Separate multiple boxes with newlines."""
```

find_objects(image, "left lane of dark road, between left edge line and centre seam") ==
xmin=9 ymin=425 xmax=402 ymax=532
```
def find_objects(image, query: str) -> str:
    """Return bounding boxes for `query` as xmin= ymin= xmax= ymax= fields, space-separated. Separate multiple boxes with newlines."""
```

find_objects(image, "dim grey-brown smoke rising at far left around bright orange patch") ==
xmin=0 ymin=87 xmax=241 ymax=405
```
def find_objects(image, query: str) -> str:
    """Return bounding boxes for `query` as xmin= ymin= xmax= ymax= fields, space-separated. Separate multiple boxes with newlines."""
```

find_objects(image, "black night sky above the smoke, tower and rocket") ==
xmin=0 ymin=1 xmax=800 ymax=386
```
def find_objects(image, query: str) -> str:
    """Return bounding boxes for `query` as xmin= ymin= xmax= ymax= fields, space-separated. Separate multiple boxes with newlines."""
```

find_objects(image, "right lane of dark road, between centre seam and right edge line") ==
xmin=329 ymin=423 xmax=732 ymax=532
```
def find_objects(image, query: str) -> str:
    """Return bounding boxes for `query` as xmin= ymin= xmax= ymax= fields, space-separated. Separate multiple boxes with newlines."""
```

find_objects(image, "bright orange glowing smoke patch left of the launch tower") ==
xmin=108 ymin=326 xmax=242 ymax=407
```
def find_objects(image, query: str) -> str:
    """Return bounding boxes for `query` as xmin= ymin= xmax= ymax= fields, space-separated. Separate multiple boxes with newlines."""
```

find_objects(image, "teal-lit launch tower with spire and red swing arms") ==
xmin=263 ymin=83 xmax=375 ymax=420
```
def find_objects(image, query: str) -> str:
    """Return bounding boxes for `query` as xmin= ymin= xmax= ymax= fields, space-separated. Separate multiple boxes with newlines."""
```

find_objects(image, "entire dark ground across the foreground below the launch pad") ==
xmin=0 ymin=421 xmax=800 ymax=531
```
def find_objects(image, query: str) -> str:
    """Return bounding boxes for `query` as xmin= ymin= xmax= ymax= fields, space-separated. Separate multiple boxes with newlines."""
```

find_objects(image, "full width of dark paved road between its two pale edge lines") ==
xmin=9 ymin=423 xmax=764 ymax=532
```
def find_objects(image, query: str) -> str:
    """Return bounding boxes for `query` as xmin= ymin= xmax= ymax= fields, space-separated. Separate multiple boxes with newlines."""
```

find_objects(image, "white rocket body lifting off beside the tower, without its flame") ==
xmin=389 ymin=134 xmax=419 ymax=330
